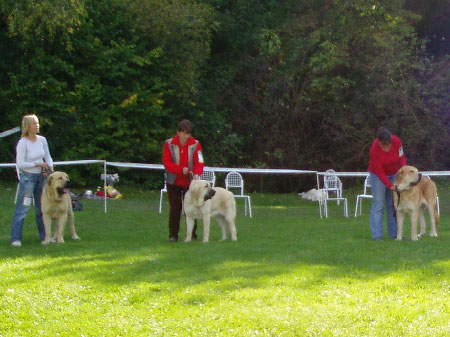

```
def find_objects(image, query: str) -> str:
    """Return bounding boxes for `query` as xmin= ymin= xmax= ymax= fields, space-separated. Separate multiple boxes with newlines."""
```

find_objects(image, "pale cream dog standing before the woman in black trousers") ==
xmin=183 ymin=180 xmax=237 ymax=242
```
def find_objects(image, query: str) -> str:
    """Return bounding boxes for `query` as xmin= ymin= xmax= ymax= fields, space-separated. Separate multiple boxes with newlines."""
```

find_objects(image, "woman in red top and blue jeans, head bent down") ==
xmin=369 ymin=128 xmax=406 ymax=241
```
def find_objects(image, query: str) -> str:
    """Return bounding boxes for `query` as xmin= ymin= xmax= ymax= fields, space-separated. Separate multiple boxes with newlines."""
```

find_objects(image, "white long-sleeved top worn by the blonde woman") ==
xmin=16 ymin=135 xmax=53 ymax=173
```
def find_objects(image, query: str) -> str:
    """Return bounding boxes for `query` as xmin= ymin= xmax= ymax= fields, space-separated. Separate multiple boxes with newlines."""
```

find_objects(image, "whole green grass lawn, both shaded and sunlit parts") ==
xmin=0 ymin=185 xmax=450 ymax=337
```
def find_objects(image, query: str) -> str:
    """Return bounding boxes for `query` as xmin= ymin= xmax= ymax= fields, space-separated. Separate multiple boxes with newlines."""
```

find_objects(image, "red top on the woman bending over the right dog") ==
xmin=369 ymin=135 xmax=406 ymax=188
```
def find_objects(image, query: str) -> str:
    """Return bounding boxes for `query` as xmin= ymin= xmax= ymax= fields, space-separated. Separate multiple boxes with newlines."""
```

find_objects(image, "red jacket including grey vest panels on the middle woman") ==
xmin=162 ymin=135 xmax=204 ymax=187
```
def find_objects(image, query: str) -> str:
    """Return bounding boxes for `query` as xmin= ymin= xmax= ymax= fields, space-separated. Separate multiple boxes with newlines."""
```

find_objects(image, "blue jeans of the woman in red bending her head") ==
xmin=370 ymin=173 xmax=397 ymax=239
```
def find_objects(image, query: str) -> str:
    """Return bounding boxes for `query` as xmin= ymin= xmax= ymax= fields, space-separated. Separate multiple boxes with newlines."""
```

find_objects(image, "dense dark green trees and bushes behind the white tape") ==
xmin=0 ymin=0 xmax=450 ymax=189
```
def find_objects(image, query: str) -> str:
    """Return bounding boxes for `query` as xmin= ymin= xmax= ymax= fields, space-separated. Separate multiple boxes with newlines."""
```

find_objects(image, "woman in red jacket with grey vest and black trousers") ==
xmin=162 ymin=119 xmax=204 ymax=242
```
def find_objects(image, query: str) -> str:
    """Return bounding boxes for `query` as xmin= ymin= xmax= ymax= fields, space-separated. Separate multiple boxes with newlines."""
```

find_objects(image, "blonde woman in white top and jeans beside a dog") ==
xmin=11 ymin=115 xmax=53 ymax=247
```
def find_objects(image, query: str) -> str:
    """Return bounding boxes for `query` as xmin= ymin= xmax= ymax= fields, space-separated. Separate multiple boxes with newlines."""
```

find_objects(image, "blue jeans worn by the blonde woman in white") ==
xmin=11 ymin=171 xmax=47 ymax=242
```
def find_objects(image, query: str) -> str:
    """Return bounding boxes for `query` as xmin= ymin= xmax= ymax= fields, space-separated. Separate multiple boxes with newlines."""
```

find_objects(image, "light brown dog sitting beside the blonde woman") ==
xmin=41 ymin=171 xmax=80 ymax=245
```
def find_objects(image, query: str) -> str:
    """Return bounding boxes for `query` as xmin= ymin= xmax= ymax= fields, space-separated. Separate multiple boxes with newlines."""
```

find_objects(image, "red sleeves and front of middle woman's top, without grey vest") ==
xmin=162 ymin=135 xmax=204 ymax=187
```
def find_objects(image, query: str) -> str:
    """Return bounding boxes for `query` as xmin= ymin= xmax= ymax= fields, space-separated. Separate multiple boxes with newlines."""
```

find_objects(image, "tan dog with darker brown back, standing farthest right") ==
xmin=394 ymin=166 xmax=439 ymax=241
